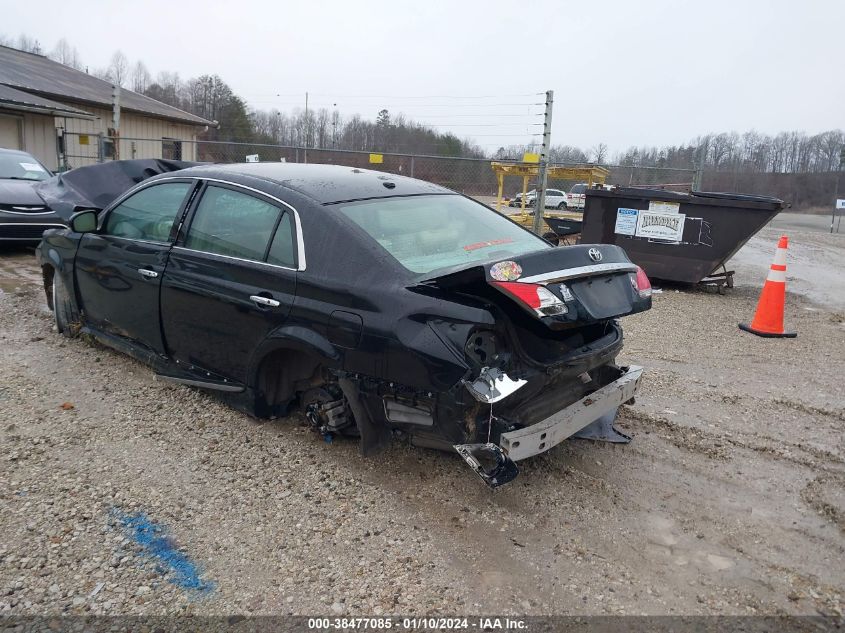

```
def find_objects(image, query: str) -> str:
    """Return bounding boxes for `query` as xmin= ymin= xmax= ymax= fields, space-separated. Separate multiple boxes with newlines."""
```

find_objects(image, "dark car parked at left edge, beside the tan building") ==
xmin=0 ymin=148 xmax=64 ymax=244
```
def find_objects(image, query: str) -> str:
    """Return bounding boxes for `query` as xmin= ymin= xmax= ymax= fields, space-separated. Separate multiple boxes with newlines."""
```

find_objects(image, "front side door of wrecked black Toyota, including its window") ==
xmin=76 ymin=180 xmax=194 ymax=354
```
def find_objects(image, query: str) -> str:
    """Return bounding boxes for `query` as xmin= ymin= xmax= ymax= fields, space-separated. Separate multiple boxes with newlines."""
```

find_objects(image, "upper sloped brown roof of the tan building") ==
xmin=0 ymin=46 xmax=215 ymax=125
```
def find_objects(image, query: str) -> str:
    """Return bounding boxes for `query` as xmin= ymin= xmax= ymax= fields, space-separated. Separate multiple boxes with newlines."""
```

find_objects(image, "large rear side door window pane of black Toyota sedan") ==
xmin=185 ymin=186 xmax=281 ymax=261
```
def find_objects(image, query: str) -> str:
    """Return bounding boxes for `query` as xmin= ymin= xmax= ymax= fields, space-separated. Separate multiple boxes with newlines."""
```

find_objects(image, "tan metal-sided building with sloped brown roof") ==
xmin=0 ymin=46 xmax=216 ymax=170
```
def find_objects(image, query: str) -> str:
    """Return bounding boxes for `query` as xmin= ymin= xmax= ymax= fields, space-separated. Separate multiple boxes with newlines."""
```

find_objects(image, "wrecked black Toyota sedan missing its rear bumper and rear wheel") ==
xmin=37 ymin=163 xmax=651 ymax=485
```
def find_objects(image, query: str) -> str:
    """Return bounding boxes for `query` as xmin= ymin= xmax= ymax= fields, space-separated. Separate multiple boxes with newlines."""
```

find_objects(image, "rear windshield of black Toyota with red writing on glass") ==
xmin=340 ymin=195 xmax=552 ymax=274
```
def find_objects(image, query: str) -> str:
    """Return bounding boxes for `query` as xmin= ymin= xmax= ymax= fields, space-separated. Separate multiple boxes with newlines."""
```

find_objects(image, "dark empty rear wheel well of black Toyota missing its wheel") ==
xmin=255 ymin=348 xmax=328 ymax=417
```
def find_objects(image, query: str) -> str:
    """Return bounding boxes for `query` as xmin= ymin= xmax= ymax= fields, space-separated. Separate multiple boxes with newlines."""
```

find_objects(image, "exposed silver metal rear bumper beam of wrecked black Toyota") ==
xmin=499 ymin=365 xmax=643 ymax=461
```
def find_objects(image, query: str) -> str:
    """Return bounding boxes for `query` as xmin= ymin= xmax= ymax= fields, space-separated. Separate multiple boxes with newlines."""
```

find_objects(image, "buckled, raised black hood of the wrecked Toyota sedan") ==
xmin=35 ymin=158 xmax=202 ymax=220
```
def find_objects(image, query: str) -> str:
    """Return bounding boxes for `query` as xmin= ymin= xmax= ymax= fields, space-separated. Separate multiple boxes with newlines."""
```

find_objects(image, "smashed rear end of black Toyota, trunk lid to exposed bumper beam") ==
xmin=421 ymin=245 xmax=651 ymax=487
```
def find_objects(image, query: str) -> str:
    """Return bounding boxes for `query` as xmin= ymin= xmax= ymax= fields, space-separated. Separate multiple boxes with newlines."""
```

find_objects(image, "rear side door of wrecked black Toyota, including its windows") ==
xmin=161 ymin=182 xmax=299 ymax=383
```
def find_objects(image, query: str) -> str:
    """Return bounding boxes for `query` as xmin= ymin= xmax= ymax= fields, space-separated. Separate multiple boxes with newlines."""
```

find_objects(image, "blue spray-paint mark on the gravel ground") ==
xmin=111 ymin=508 xmax=214 ymax=593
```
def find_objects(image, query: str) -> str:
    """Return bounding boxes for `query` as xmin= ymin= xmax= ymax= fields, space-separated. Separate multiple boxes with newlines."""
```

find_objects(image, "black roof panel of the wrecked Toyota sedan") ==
xmin=169 ymin=163 xmax=455 ymax=204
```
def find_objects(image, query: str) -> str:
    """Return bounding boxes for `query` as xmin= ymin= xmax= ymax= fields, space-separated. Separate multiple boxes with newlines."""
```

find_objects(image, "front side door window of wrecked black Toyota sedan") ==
xmin=105 ymin=182 xmax=191 ymax=242
